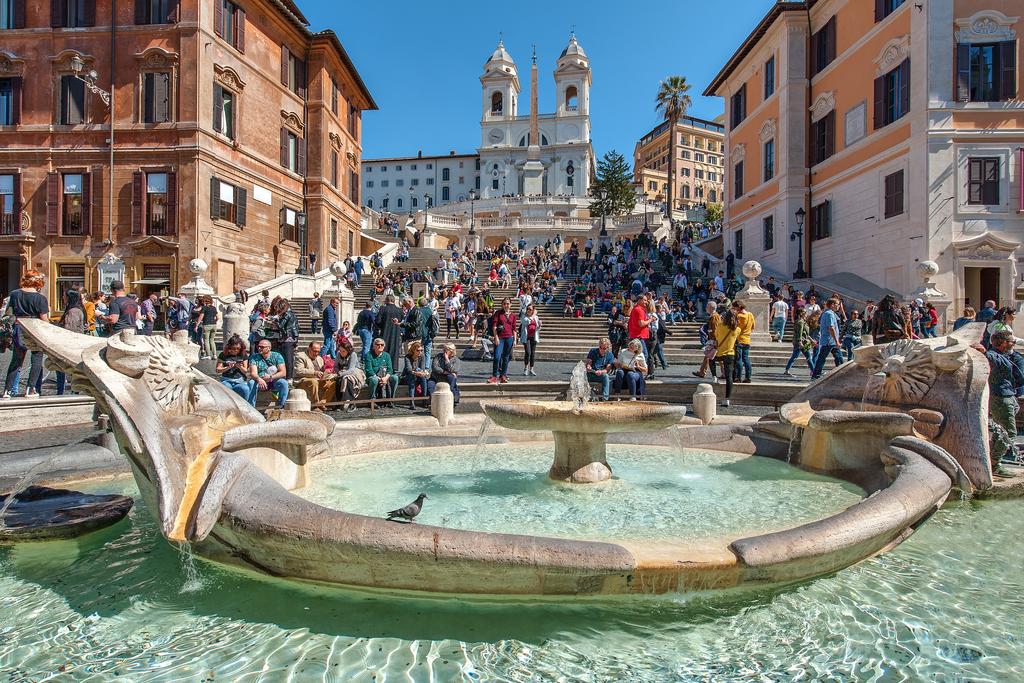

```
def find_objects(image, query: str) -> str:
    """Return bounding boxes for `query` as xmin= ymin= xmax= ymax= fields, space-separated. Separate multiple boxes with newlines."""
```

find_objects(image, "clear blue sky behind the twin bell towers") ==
xmin=299 ymin=0 xmax=773 ymax=159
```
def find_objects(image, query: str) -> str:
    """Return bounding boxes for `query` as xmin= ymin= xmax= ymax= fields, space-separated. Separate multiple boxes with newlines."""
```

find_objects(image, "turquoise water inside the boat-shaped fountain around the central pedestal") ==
xmin=298 ymin=443 xmax=864 ymax=540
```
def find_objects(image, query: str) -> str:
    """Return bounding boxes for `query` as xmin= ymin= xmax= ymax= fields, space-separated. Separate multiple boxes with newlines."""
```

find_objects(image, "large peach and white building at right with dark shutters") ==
xmin=705 ymin=0 xmax=1024 ymax=314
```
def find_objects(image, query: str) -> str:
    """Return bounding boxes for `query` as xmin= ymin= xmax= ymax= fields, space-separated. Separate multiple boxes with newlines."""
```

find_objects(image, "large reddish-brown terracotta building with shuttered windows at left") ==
xmin=0 ymin=0 xmax=376 ymax=308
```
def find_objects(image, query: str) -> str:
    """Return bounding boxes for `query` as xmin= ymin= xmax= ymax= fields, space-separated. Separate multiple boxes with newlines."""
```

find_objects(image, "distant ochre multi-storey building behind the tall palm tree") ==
xmin=633 ymin=117 xmax=725 ymax=210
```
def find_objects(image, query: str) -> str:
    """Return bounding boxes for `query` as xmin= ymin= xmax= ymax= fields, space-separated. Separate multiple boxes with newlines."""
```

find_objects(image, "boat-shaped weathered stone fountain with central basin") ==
xmin=2 ymin=313 xmax=992 ymax=596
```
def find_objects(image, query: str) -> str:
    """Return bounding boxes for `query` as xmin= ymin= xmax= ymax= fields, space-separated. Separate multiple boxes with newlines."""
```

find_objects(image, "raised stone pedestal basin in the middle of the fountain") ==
xmin=483 ymin=400 xmax=686 ymax=483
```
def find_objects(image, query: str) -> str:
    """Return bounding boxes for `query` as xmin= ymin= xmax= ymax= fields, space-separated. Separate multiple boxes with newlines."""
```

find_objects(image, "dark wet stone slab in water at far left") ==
xmin=0 ymin=486 xmax=134 ymax=542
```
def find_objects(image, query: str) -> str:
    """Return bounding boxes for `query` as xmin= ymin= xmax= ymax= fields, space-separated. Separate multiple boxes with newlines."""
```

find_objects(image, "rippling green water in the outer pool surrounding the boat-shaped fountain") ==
xmin=0 ymin=473 xmax=1024 ymax=683
